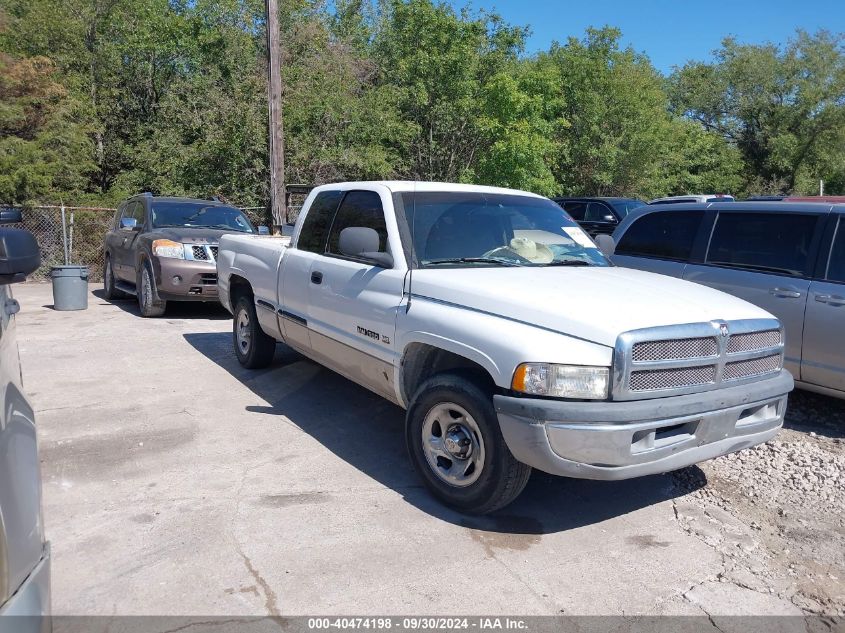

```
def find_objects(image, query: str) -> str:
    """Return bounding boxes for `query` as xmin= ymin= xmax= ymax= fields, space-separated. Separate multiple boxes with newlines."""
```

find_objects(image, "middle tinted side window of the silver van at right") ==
xmin=707 ymin=212 xmax=818 ymax=276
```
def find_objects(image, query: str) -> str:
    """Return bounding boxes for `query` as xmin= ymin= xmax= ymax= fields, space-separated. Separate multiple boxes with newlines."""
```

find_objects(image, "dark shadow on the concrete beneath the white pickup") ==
xmin=184 ymin=333 xmax=706 ymax=535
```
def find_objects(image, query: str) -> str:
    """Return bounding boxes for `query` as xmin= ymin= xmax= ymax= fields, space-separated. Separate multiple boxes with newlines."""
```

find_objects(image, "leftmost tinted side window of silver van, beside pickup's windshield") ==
xmin=616 ymin=211 xmax=704 ymax=261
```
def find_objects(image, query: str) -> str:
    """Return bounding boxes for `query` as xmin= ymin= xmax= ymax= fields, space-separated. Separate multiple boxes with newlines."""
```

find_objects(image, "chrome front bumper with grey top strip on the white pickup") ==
xmin=494 ymin=370 xmax=794 ymax=480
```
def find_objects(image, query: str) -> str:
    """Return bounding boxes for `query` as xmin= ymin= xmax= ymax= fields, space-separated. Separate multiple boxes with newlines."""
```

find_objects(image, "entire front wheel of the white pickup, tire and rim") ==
xmin=405 ymin=374 xmax=531 ymax=514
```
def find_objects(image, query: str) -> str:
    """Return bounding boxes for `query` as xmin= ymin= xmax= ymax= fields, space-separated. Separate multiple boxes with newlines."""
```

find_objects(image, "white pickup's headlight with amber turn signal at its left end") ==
xmin=511 ymin=363 xmax=610 ymax=400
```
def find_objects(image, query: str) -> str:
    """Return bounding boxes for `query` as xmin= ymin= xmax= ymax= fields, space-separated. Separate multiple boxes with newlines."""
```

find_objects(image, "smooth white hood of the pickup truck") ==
xmin=412 ymin=266 xmax=772 ymax=347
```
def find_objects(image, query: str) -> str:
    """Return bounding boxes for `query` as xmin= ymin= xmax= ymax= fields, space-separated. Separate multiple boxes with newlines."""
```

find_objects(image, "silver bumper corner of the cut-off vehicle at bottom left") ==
xmin=0 ymin=543 xmax=52 ymax=633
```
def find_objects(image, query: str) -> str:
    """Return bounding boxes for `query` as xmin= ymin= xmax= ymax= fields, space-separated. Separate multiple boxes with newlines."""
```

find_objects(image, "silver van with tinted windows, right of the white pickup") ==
xmin=600 ymin=202 xmax=845 ymax=398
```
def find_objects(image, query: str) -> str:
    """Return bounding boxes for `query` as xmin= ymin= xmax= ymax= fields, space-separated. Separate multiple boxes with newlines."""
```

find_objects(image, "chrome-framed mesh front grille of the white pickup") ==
xmin=612 ymin=319 xmax=783 ymax=400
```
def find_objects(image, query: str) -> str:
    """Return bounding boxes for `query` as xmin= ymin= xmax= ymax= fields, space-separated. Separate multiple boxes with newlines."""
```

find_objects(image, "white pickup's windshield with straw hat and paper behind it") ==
xmin=397 ymin=191 xmax=610 ymax=268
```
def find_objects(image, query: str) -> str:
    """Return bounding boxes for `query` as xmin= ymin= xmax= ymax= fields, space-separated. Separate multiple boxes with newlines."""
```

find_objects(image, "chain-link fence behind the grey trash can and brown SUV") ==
xmin=4 ymin=206 xmax=267 ymax=281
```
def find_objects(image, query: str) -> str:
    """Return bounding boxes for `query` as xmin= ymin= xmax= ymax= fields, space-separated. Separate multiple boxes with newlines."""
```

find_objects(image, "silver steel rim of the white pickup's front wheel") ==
xmin=421 ymin=402 xmax=485 ymax=488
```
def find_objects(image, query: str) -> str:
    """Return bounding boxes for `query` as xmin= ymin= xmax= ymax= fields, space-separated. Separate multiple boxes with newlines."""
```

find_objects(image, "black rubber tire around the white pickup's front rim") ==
xmin=405 ymin=373 xmax=531 ymax=514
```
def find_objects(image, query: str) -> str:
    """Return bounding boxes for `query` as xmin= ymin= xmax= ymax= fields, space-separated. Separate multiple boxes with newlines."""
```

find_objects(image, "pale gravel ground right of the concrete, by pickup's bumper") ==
xmin=673 ymin=391 xmax=845 ymax=615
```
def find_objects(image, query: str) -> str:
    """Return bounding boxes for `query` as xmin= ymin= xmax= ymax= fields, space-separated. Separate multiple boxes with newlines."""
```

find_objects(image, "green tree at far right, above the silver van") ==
xmin=670 ymin=31 xmax=845 ymax=193
